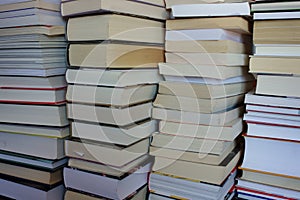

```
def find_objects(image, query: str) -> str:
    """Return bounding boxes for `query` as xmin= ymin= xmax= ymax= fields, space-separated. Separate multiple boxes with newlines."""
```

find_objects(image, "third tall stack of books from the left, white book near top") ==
xmin=149 ymin=0 xmax=254 ymax=199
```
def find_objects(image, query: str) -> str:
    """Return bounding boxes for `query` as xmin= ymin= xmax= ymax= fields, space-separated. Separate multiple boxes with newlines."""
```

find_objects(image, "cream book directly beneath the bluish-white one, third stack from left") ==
xmin=165 ymin=40 xmax=250 ymax=54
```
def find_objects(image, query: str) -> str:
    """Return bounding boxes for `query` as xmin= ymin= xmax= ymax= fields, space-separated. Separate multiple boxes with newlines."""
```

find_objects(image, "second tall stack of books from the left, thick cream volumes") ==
xmin=62 ymin=0 xmax=167 ymax=200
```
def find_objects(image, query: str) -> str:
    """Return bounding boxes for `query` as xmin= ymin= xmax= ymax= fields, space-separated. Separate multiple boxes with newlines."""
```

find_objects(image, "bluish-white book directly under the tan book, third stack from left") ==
xmin=166 ymin=28 xmax=250 ymax=43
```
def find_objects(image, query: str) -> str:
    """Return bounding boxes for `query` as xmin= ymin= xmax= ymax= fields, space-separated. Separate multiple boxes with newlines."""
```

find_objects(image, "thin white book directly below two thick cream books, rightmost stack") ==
xmin=245 ymin=91 xmax=300 ymax=109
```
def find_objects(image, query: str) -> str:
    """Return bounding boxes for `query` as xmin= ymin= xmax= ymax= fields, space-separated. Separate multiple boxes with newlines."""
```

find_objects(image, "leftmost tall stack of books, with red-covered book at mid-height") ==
xmin=0 ymin=0 xmax=69 ymax=200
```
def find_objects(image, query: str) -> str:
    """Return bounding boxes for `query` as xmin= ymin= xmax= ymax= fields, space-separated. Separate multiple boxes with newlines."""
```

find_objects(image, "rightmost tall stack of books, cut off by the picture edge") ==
xmin=237 ymin=1 xmax=300 ymax=199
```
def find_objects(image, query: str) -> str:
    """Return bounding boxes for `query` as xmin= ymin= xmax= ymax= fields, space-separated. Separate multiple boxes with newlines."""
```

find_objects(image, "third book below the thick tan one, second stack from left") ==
xmin=67 ymin=103 xmax=152 ymax=126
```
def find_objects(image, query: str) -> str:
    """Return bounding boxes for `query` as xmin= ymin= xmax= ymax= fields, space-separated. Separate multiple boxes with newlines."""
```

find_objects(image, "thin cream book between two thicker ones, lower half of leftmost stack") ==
xmin=0 ymin=123 xmax=70 ymax=138
